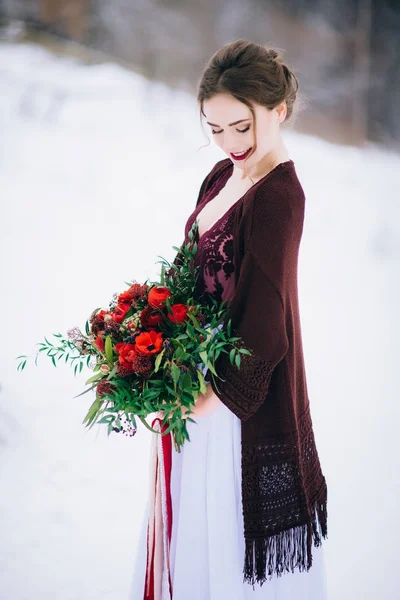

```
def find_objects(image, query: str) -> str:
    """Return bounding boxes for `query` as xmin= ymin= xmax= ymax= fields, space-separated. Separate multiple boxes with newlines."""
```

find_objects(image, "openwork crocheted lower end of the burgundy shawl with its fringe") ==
xmin=242 ymin=404 xmax=328 ymax=585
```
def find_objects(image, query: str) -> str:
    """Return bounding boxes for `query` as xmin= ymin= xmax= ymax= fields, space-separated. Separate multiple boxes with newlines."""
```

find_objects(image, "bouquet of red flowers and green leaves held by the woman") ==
xmin=17 ymin=221 xmax=250 ymax=452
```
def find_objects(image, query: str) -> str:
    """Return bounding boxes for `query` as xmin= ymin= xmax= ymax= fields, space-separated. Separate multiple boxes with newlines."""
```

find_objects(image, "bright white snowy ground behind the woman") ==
xmin=0 ymin=43 xmax=400 ymax=600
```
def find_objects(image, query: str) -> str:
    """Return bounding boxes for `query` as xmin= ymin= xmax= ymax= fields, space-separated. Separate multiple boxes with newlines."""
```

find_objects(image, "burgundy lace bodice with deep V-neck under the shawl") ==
xmin=185 ymin=162 xmax=237 ymax=303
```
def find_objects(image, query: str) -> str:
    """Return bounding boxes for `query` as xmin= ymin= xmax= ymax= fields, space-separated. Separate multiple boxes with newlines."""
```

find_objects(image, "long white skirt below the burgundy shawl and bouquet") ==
xmin=130 ymin=403 xmax=327 ymax=600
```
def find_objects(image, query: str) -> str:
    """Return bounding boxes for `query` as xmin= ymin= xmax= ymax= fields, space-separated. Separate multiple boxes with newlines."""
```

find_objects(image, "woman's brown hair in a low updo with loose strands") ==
xmin=197 ymin=39 xmax=299 ymax=176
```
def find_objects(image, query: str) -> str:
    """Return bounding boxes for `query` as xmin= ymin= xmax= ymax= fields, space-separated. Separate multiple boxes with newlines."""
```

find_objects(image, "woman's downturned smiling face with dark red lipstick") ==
xmin=203 ymin=93 xmax=286 ymax=170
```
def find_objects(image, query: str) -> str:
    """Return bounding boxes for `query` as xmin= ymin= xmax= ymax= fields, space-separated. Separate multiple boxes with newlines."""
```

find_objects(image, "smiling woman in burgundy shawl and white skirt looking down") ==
xmin=132 ymin=40 xmax=327 ymax=600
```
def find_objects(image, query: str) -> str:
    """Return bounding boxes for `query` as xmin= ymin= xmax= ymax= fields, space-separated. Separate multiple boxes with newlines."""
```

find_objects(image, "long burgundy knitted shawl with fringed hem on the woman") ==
xmin=169 ymin=159 xmax=327 ymax=585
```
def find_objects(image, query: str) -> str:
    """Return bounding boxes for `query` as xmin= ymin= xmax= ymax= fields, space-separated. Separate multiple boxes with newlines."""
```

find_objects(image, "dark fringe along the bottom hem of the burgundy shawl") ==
xmin=243 ymin=497 xmax=328 ymax=589
